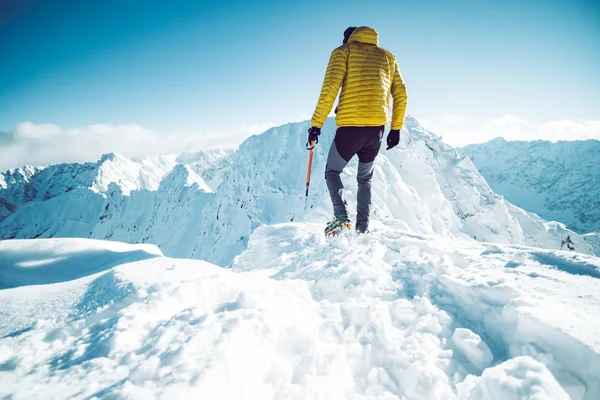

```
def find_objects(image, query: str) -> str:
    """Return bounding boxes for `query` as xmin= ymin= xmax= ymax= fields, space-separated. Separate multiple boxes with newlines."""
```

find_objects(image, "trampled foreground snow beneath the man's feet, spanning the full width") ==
xmin=0 ymin=230 xmax=600 ymax=400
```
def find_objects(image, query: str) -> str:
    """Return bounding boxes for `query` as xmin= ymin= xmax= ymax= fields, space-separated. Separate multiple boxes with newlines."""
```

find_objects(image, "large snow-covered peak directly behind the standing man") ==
xmin=194 ymin=117 xmax=591 ymax=265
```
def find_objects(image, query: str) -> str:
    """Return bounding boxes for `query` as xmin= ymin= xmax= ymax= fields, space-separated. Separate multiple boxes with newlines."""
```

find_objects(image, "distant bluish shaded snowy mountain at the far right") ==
xmin=458 ymin=138 xmax=600 ymax=233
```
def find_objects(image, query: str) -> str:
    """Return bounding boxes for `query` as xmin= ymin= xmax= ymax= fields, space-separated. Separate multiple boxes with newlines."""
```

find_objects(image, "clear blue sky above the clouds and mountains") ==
xmin=0 ymin=0 xmax=600 ymax=166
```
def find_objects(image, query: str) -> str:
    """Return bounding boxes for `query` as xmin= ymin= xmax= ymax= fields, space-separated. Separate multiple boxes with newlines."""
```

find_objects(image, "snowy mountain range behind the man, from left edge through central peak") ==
xmin=0 ymin=117 xmax=592 ymax=266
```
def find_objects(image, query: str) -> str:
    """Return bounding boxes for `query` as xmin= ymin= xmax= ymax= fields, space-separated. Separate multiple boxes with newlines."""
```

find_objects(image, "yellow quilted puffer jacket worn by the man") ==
xmin=312 ymin=26 xmax=407 ymax=129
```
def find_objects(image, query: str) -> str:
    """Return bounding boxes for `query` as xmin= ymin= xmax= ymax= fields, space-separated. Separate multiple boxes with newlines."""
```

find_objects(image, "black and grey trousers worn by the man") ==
xmin=325 ymin=126 xmax=384 ymax=230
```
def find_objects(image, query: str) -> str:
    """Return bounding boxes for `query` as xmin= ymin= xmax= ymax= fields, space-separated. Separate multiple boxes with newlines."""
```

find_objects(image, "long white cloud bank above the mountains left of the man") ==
xmin=0 ymin=122 xmax=274 ymax=171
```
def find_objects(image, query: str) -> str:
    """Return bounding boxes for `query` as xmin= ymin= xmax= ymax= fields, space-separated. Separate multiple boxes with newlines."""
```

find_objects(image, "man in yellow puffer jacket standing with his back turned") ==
xmin=308 ymin=26 xmax=407 ymax=235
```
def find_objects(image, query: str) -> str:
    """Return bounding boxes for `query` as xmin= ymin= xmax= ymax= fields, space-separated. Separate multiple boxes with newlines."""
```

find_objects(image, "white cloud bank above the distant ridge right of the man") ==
xmin=430 ymin=115 xmax=600 ymax=146
